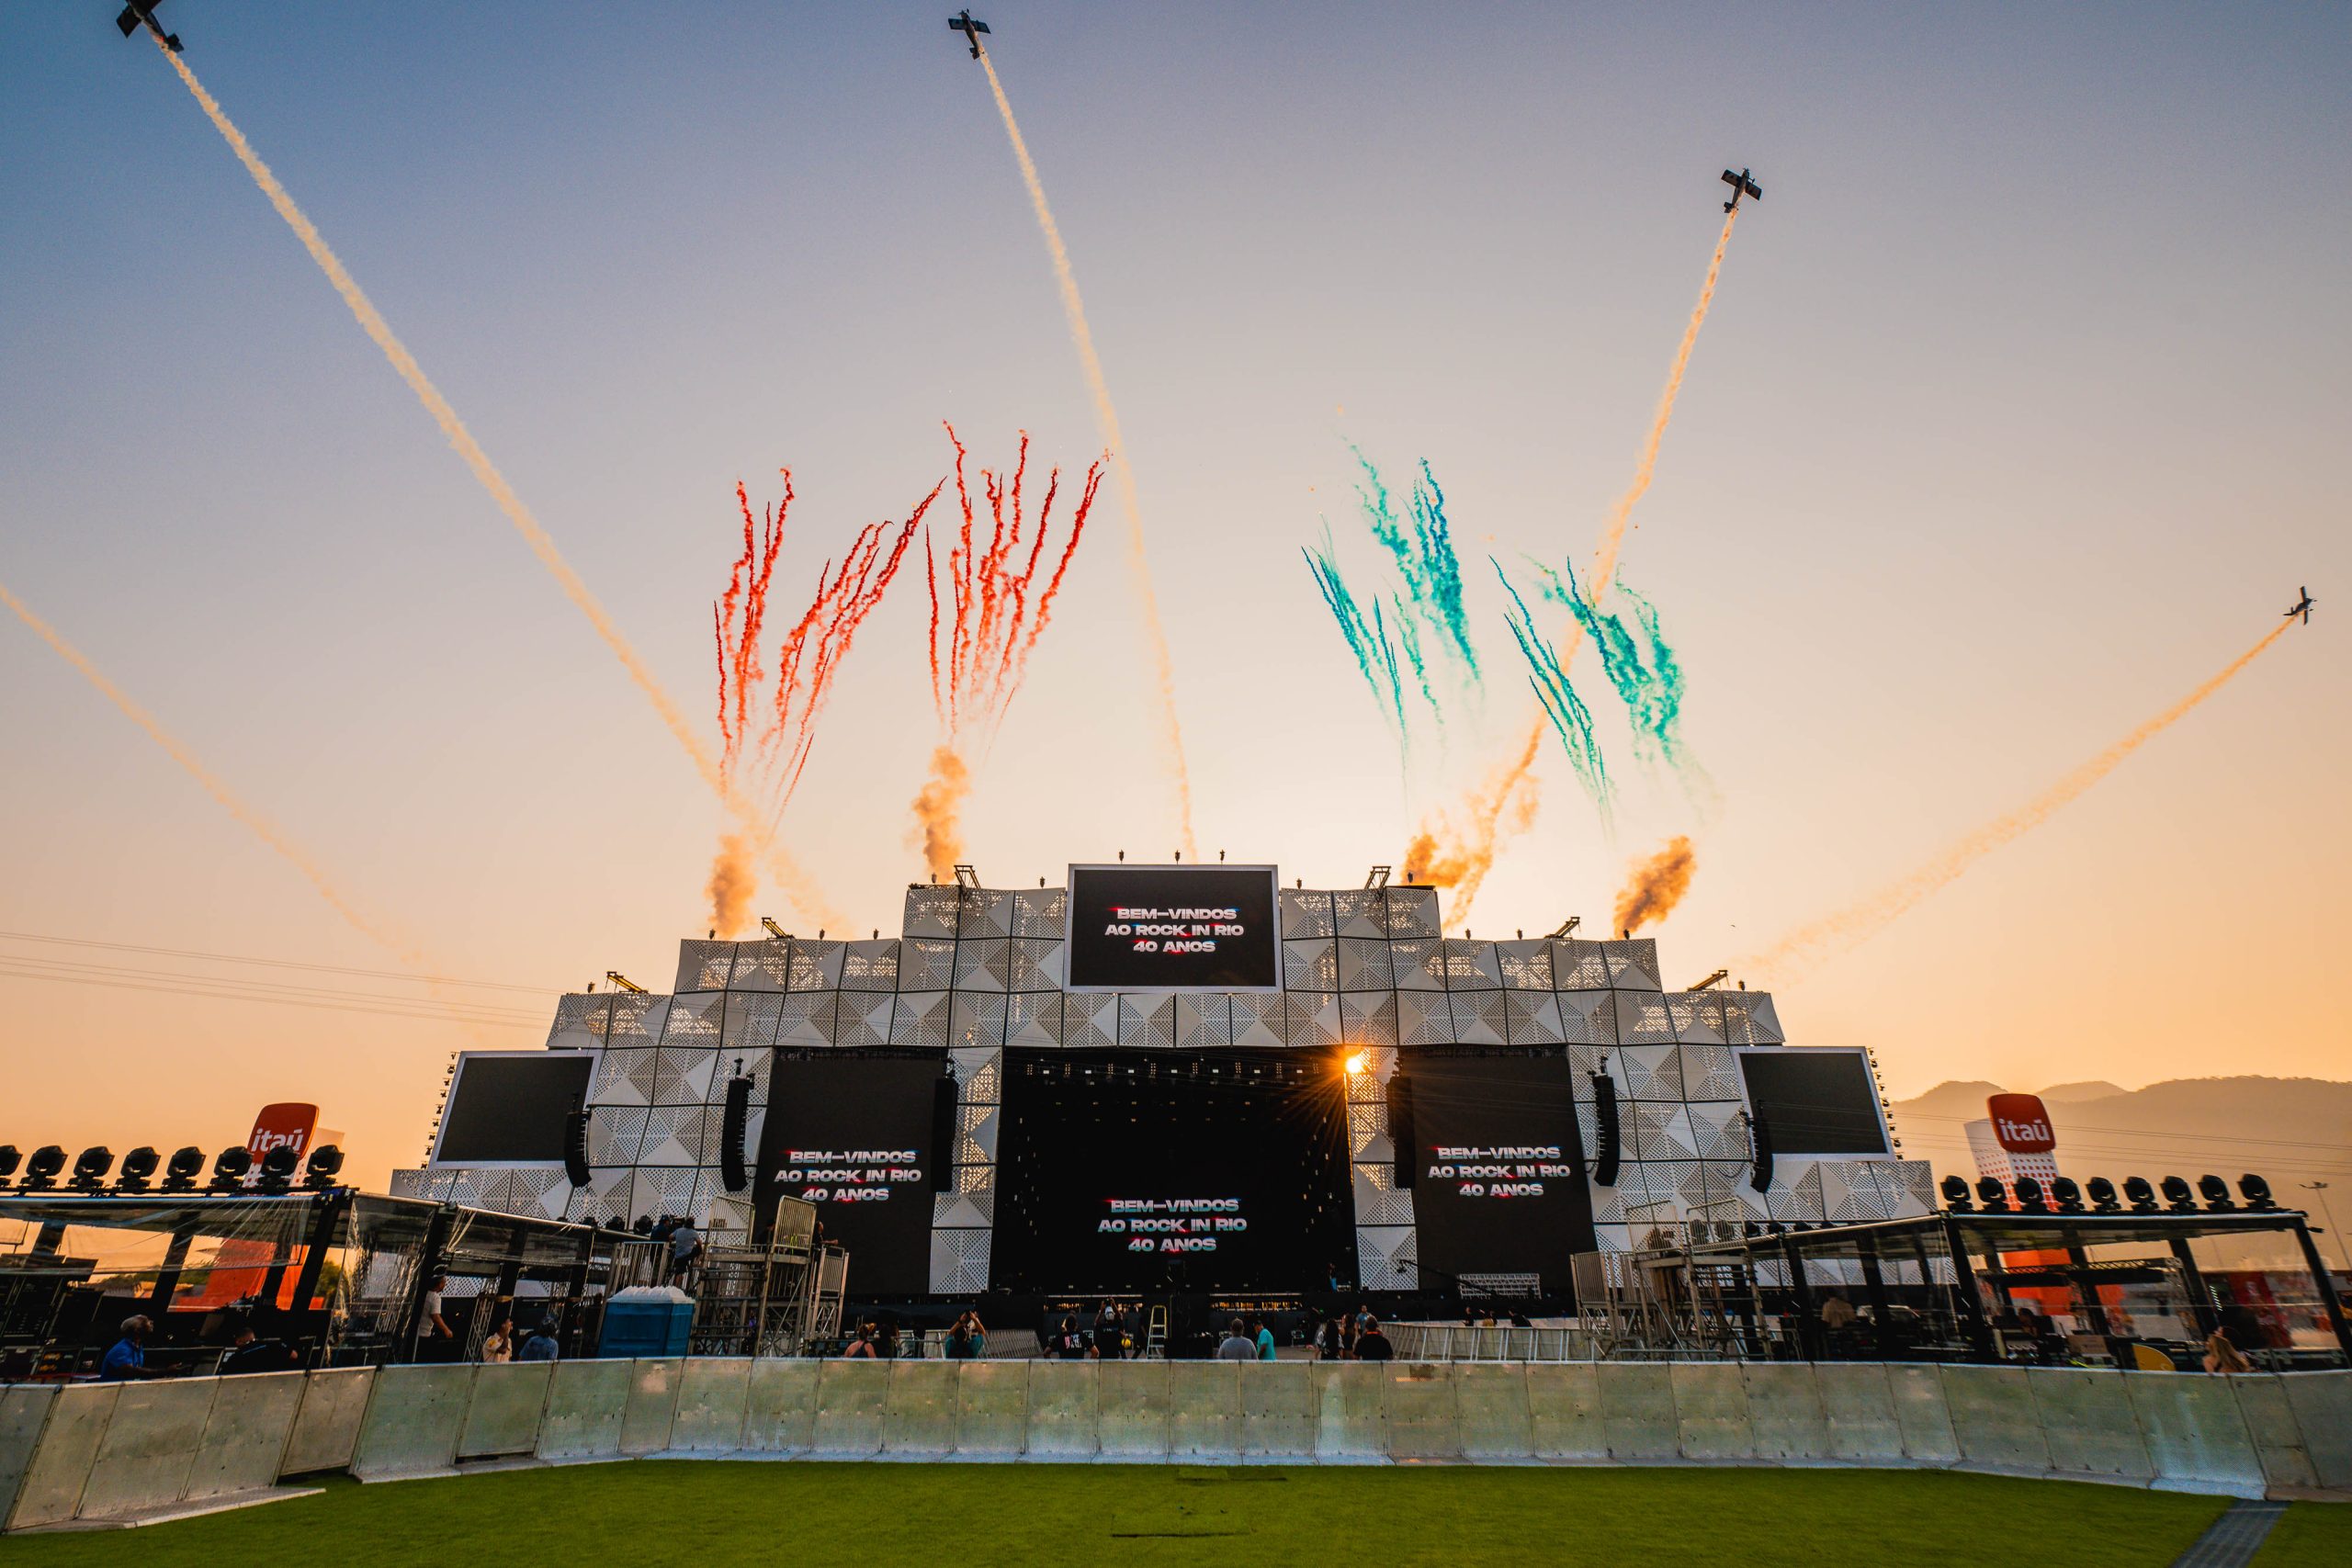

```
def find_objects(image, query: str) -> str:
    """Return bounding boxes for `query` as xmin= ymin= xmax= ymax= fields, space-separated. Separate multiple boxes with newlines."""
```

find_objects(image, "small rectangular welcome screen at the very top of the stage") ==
xmin=1066 ymin=865 xmax=1282 ymax=992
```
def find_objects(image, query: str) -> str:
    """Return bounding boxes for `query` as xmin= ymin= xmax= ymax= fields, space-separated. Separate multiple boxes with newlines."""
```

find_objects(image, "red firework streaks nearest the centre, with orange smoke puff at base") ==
xmin=915 ymin=425 xmax=1103 ymax=877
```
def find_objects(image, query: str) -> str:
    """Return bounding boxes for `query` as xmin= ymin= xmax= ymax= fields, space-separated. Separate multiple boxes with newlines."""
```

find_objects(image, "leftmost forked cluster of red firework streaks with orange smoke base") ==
xmin=708 ymin=468 xmax=945 ymax=936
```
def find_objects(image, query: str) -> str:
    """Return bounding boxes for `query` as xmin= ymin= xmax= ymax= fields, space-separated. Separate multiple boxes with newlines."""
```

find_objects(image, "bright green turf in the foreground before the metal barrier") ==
xmin=0 ymin=1460 xmax=2248 ymax=1568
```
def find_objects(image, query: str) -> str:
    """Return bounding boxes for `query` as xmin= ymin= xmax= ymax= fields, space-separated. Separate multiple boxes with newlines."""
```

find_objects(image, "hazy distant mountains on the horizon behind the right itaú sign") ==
xmin=1886 ymin=1077 xmax=2352 ymax=1258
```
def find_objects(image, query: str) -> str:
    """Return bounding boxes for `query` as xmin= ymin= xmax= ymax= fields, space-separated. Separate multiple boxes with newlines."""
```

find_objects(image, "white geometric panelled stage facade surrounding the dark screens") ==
xmin=393 ymin=886 xmax=1931 ymax=1295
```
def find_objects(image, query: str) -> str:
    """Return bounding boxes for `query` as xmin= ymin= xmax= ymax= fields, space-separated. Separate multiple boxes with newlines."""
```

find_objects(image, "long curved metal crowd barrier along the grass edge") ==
xmin=0 ymin=1357 xmax=2352 ymax=1530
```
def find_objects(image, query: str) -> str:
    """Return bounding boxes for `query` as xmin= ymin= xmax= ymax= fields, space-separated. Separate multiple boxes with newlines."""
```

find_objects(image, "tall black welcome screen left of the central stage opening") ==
xmin=752 ymin=1051 xmax=953 ymax=1298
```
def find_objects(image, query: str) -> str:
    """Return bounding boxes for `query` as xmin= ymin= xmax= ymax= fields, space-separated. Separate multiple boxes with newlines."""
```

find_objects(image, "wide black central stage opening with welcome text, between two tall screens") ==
xmin=990 ymin=1048 xmax=1355 ymax=1293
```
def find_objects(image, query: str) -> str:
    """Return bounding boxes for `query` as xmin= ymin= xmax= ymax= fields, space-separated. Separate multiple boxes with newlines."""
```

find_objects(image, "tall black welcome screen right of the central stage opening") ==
xmin=1397 ymin=1046 xmax=1597 ymax=1293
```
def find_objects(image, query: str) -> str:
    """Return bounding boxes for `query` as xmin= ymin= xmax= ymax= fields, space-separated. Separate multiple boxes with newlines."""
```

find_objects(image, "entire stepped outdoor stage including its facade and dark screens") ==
xmin=393 ymin=865 xmax=1931 ymax=1325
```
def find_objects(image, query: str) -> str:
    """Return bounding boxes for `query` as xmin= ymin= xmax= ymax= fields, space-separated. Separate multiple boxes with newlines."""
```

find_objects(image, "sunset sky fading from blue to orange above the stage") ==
xmin=0 ymin=0 xmax=2352 ymax=1180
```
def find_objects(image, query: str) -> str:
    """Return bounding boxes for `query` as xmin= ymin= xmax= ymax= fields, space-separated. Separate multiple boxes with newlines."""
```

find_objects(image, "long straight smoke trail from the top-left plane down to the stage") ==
xmin=155 ymin=42 xmax=847 ymax=924
